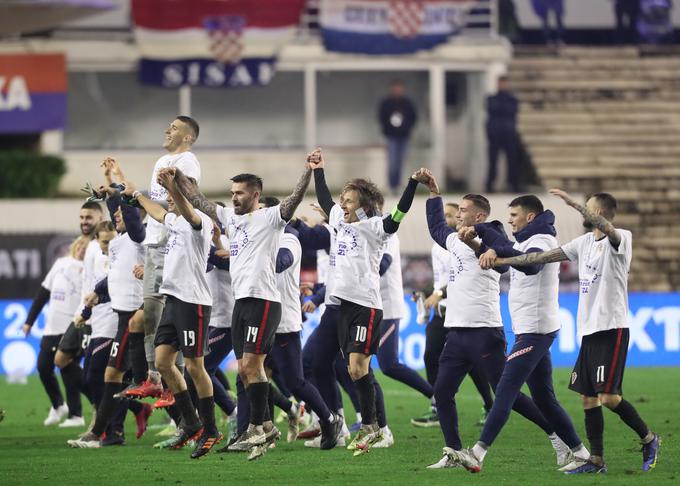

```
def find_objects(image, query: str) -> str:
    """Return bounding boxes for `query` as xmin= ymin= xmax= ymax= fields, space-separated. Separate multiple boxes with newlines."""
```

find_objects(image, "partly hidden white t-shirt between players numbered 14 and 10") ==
xmin=276 ymin=233 xmax=302 ymax=334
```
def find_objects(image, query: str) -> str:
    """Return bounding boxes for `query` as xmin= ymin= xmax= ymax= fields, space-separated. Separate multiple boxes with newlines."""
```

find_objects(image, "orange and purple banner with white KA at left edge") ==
xmin=0 ymin=54 xmax=67 ymax=133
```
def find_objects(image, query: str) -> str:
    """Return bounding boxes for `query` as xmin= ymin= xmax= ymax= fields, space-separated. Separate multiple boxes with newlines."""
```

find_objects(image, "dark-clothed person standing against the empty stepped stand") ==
xmin=486 ymin=76 xmax=519 ymax=193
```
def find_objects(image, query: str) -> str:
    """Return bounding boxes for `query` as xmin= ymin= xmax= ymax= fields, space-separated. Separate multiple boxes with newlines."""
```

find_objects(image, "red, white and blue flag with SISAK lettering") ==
xmin=132 ymin=0 xmax=305 ymax=88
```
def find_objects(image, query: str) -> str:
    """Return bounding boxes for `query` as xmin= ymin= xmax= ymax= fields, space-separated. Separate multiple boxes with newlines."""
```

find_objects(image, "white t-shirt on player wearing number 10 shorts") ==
xmin=326 ymin=205 xmax=392 ymax=309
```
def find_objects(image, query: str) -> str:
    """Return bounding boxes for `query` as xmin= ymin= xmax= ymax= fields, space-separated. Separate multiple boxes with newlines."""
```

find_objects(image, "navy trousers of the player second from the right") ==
xmin=479 ymin=332 xmax=581 ymax=448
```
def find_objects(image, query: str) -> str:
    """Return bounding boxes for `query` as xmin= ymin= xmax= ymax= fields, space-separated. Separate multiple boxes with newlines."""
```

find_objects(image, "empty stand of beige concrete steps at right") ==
xmin=509 ymin=47 xmax=680 ymax=291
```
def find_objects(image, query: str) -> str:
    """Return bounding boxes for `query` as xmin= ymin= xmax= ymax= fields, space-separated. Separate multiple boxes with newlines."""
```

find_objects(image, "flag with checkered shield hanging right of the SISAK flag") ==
xmin=320 ymin=0 xmax=475 ymax=55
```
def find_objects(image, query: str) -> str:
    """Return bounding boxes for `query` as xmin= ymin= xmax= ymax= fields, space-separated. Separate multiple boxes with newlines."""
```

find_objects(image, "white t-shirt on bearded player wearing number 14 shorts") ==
xmin=216 ymin=206 xmax=286 ymax=302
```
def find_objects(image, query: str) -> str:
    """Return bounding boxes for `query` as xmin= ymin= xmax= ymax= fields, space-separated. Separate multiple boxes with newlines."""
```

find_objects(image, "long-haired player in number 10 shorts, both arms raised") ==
xmin=310 ymin=150 xmax=418 ymax=455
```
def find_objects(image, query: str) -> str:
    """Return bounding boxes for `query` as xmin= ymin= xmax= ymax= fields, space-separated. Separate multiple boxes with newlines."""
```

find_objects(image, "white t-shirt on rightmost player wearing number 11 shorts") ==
xmin=562 ymin=229 xmax=633 ymax=337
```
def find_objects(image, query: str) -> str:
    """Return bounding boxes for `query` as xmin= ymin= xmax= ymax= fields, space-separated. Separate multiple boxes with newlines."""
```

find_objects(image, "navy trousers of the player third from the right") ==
xmin=434 ymin=327 xmax=553 ymax=450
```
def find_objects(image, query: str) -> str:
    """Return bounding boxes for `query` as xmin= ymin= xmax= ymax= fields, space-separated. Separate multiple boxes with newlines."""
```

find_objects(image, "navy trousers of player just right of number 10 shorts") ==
xmin=378 ymin=319 xmax=433 ymax=398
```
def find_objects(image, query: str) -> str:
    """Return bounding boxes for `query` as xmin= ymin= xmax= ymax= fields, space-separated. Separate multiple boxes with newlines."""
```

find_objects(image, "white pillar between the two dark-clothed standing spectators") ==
xmin=430 ymin=66 xmax=446 ymax=190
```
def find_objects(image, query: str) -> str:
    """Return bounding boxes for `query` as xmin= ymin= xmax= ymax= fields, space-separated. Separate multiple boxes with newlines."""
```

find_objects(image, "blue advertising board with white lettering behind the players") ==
xmin=0 ymin=293 xmax=680 ymax=375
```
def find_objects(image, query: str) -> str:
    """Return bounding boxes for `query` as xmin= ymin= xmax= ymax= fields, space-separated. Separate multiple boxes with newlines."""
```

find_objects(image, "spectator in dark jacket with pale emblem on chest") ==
xmin=378 ymin=79 xmax=417 ymax=194
